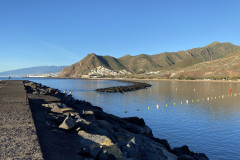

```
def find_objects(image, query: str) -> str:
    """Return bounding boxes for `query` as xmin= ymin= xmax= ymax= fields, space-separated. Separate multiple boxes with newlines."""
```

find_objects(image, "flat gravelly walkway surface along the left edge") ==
xmin=0 ymin=81 xmax=43 ymax=159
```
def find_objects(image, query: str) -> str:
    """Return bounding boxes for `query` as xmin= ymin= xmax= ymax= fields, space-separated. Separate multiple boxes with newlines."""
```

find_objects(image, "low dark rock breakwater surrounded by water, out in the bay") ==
xmin=96 ymin=80 xmax=152 ymax=93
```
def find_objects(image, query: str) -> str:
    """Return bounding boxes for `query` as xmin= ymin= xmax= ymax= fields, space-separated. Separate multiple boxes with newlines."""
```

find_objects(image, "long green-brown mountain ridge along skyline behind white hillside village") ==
xmin=61 ymin=42 xmax=240 ymax=77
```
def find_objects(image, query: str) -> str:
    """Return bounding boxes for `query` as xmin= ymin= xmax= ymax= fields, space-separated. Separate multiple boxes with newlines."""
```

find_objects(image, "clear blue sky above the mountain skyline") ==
xmin=0 ymin=0 xmax=240 ymax=72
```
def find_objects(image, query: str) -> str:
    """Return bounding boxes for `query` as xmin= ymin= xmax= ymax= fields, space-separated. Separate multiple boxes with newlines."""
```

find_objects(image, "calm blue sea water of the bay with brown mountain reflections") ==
xmin=0 ymin=78 xmax=240 ymax=160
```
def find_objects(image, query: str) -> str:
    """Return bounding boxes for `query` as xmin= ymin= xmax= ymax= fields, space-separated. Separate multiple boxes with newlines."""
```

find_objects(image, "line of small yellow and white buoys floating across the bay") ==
xmin=125 ymin=88 xmax=240 ymax=113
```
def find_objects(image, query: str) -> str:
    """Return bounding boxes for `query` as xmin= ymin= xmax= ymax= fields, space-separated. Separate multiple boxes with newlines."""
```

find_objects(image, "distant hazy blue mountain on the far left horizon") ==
xmin=0 ymin=66 xmax=66 ymax=77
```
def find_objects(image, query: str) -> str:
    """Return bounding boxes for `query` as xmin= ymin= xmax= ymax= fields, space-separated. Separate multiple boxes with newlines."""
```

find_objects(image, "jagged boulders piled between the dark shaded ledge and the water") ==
xmin=25 ymin=81 xmax=208 ymax=160
